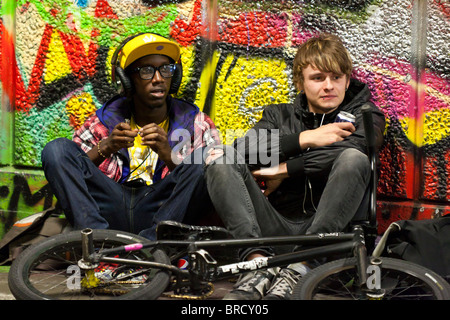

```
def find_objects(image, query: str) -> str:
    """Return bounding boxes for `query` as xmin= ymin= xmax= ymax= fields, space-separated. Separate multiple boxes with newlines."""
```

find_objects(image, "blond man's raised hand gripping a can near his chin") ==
xmin=299 ymin=122 xmax=356 ymax=149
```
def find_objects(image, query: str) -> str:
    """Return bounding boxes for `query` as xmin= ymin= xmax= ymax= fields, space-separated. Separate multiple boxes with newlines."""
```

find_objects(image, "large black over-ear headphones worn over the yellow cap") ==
xmin=111 ymin=32 xmax=183 ymax=96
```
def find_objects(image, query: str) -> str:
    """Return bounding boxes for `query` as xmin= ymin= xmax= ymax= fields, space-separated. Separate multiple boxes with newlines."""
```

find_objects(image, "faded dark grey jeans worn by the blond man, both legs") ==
xmin=205 ymin=147 xmax=370 ymax=258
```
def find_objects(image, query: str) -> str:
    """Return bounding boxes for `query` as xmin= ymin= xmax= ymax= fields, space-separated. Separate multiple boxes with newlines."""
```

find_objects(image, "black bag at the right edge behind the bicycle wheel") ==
xmin=386 ymin=215 xmax=450 ymax=279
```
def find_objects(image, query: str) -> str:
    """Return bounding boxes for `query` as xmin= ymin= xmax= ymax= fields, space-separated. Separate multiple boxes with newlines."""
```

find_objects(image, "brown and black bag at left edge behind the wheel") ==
xmin=0 ymin=207 xmax=69 ymax=265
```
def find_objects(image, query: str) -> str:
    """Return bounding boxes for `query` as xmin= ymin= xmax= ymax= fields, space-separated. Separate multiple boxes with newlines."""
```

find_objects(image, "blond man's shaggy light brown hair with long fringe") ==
xmin=293 ymin=34 xmax=353 ymax=89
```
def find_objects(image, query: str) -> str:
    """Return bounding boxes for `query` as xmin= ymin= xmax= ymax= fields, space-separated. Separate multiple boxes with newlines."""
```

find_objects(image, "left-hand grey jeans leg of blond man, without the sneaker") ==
xmin=206 ymin=147 xmax=306 ymax=259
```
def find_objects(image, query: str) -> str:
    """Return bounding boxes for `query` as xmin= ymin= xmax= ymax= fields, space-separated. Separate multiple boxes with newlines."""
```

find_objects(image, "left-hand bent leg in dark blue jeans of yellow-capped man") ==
xmin=42 ymin=138 xmax=128 ymax=230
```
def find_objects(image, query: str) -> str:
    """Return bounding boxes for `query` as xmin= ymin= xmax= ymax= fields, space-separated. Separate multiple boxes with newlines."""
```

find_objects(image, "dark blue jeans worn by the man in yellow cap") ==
xmin=42 ymin=138 xmax=210 ymax=240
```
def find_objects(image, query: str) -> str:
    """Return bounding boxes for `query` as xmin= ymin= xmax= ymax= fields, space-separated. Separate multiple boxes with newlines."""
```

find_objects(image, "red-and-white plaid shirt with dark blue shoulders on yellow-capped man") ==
xmin=73 ymin=97 xmax=220 ymax=182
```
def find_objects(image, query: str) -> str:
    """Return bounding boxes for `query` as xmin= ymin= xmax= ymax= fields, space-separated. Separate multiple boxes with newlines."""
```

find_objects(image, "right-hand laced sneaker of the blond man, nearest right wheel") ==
xmin=263 ymin=263 xmax=309 ymax=300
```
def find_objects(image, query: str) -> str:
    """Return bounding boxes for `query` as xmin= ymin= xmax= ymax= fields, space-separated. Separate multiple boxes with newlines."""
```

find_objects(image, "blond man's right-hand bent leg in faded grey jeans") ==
xmin=307 ymin=149 xmax=370 ymax=233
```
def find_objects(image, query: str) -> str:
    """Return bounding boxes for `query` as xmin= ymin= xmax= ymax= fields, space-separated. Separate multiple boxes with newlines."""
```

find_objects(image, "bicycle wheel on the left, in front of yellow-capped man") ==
xmin=8 ymin=230 xmax=170 ymax=300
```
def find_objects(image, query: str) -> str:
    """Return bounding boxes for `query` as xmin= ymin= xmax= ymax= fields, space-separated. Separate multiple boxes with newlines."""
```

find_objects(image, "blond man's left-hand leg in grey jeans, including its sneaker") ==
xmin=206 ymin=147 xmax=312 ymax=300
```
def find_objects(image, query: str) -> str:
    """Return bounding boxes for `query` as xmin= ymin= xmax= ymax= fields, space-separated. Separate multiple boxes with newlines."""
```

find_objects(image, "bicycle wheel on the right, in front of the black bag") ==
xmin=291 ymin=258 xmax=450 ymax=300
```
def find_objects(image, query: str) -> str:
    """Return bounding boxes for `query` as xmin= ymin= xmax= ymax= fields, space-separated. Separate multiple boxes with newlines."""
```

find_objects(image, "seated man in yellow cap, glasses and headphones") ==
xmin=42 ymin=33 xmax=219 ymax=239
